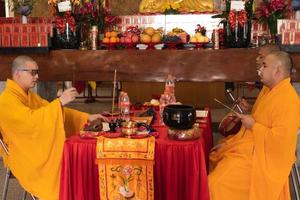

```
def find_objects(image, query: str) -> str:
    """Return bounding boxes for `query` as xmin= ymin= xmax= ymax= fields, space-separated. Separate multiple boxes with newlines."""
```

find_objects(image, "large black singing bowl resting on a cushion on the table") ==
xmin=163 ymin=105 xmax=196 ymax=130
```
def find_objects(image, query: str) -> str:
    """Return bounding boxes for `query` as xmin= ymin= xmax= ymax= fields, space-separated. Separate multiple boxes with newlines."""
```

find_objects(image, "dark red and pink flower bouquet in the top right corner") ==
xmin=255 ymin=0 xmax=291 ymax=36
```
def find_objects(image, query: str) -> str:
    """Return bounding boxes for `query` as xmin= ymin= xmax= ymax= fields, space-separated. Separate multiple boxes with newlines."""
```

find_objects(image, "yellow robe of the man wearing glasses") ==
xmin=0 ymin=79 xmax=87 ymax=200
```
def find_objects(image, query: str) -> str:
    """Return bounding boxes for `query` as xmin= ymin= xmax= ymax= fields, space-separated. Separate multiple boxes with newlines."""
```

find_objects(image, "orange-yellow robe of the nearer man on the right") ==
xmin=208 ymin=78 xmax=300 ymax=200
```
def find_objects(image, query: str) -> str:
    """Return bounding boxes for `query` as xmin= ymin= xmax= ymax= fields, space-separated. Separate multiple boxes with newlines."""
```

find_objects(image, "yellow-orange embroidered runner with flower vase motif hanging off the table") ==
xmin=97 ymin=137 xmax=155 ymax=200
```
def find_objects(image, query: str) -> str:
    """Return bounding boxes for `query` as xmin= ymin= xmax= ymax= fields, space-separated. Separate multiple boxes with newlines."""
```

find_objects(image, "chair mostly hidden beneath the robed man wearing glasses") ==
xmin=0 ymin=133 xmax=38 ymax=200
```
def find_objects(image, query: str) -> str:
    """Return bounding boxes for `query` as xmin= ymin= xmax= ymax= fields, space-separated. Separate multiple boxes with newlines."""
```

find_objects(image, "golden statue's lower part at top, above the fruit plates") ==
xmin=139 ymin=0 xmax=213 ymax=13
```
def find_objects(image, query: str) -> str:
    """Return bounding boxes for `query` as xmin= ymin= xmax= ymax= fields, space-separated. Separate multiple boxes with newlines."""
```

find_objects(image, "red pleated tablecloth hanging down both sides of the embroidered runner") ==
xmin=59 ymin=108 xmax=212 ymax=200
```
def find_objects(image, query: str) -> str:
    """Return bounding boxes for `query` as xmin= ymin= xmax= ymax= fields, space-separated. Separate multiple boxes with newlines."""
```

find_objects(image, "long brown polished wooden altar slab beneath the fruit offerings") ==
xmin=0 ymin=48 xmax=300 ymax=82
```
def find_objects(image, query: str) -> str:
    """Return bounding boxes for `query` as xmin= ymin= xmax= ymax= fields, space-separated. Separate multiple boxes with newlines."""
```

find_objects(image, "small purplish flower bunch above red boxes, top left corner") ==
xmin=9 ymin=0 xmax=36 ymax=16
